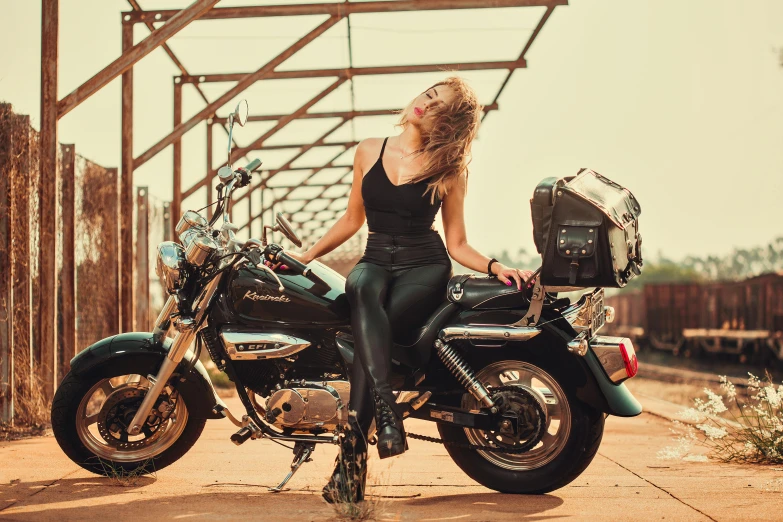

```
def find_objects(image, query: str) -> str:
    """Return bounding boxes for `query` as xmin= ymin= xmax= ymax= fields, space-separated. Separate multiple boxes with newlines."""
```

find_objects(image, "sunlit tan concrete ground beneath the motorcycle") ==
xmin=0 ymin=394 xmax=783 ymax=522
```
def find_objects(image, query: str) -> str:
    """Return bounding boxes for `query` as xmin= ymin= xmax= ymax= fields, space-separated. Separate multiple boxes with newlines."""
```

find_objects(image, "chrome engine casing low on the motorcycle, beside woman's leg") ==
xmin=266 ymin=380 xmax=351 ymax=431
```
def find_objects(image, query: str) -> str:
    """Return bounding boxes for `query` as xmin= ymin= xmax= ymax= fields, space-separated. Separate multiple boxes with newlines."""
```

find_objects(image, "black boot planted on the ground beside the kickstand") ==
xmin=322 ymin=424 xmax=367 ymax=504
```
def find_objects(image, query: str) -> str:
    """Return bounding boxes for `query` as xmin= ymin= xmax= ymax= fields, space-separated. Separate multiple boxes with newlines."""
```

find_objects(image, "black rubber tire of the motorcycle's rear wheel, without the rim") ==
xmin=438 ymin=361 xmax=605 ymax=494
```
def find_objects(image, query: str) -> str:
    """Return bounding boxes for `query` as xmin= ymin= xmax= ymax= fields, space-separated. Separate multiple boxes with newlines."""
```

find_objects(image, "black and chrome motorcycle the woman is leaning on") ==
xmin=52 ymin=98 xmax=641 ymax=493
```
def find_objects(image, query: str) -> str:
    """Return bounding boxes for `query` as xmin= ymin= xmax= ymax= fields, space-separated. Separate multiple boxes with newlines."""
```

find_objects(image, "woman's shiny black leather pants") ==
xmin=345 ymin=230 xmax=452 ymax=435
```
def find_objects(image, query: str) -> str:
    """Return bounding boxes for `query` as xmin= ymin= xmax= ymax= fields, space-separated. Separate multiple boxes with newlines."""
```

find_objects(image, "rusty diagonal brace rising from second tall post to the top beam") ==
xmin=134 ymin=16 xmax=340 ymax=168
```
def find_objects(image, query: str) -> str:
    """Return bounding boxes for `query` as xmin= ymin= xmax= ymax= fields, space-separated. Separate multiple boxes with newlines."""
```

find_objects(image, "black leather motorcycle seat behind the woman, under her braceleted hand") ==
xmin=446 ymin=274 xmax=529 ymax=310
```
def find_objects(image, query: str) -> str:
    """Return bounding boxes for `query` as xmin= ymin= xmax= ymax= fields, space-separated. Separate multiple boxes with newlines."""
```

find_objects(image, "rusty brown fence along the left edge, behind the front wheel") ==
xmin=0 ymin=104 xmax=169 ymax=425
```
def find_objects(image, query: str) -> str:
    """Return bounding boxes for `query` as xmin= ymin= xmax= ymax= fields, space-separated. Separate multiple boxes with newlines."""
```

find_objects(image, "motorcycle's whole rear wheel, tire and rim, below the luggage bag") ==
xmin=438 ymin=360 xmax=604 ymax=494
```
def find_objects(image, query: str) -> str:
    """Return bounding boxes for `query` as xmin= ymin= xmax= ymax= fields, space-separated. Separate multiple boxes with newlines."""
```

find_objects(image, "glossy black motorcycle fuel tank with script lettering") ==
xmin=225 ymin=261 xmax=350 ymax=326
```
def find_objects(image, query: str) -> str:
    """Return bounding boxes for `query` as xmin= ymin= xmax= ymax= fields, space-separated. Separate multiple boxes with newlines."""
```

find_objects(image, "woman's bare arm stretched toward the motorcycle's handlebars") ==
xmin=295 ymin=140 xmax=371 ymax=263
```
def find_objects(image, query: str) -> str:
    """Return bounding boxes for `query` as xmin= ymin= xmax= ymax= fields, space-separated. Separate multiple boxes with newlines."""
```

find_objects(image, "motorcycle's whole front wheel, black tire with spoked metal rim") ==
xmin=52 ymin=366 xmax=206 ymax=476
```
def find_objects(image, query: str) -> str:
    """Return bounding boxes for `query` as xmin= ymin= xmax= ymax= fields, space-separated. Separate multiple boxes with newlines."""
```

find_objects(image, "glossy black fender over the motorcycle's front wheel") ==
xmin=70 ymin=332 xmax=225 ymax=419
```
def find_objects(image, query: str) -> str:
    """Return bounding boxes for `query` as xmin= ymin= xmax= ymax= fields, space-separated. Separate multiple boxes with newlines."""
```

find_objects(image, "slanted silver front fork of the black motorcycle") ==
xmin=128 ymin=274 xmax=222 ymax=435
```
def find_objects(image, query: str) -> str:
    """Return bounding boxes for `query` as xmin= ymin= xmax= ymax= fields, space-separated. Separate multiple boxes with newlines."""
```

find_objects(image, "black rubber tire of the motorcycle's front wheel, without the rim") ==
xmin=52 ymin=373 xmax=206 ymax=476
